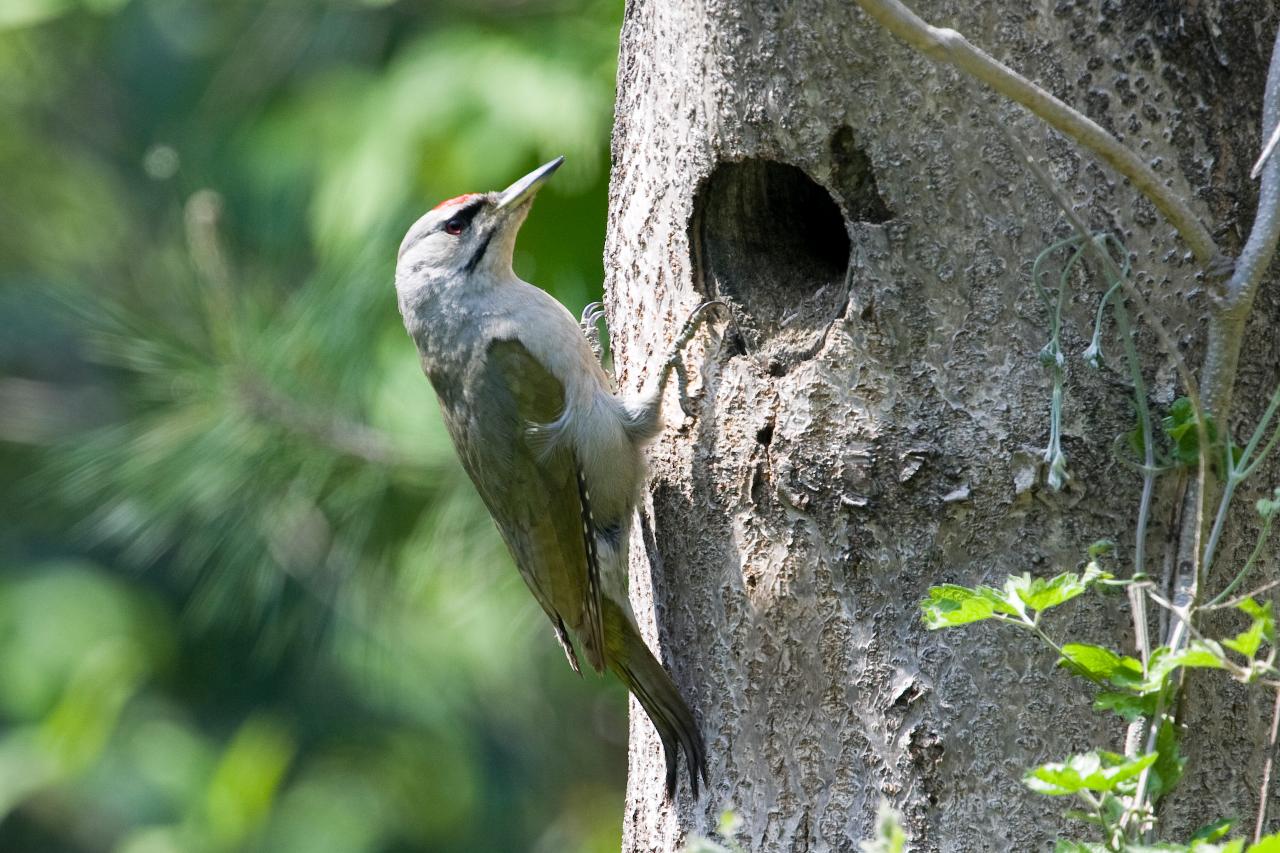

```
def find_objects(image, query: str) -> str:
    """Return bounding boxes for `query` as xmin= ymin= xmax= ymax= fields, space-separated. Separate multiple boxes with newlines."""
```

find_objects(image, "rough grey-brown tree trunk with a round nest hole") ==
xmin=605 ymin=0 xmax=1280 ymax=852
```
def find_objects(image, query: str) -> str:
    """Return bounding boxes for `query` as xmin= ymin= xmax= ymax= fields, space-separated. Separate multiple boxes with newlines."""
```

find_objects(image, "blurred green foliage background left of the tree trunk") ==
xmin=0 ymin=0 xmax=626 ymax=853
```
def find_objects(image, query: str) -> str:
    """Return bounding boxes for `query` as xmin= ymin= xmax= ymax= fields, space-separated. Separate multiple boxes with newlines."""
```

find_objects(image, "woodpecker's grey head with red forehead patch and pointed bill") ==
xmin=396 ymin=158 xmax=564 ymax=291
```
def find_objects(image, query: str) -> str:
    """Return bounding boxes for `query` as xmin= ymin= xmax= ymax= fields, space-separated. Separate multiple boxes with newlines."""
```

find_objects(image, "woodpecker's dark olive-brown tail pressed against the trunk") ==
xmin=604 ymin=598 xmax=707 ymax=800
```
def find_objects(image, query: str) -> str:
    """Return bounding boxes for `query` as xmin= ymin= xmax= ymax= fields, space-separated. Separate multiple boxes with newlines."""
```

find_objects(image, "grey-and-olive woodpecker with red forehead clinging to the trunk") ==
xmin=396 ymin=158 xmax=723 ymax=799
